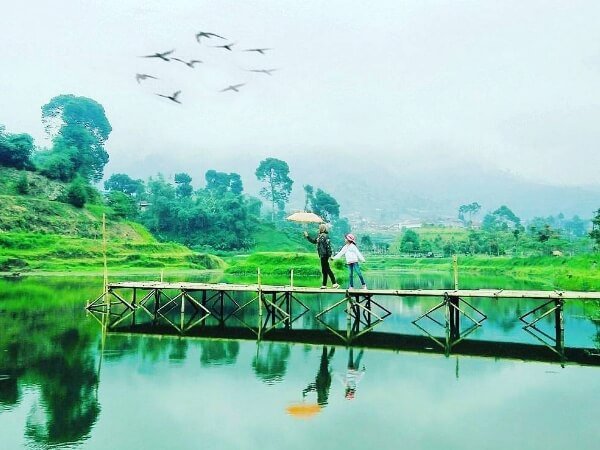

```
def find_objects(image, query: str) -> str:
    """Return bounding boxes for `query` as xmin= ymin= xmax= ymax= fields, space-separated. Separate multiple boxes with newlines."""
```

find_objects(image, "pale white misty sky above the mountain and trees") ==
xmin=0 ymin=0 xmax=600 ymax=185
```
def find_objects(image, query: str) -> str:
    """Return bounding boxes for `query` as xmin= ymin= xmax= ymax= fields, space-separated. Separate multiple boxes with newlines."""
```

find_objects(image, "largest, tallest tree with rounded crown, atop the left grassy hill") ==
xmin=42 ymin=95 xmax=112 ymax=181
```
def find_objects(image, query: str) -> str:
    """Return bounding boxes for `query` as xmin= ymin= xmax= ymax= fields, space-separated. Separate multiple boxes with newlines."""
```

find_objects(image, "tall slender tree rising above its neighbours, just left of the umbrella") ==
xmin=255 ymin=158 xmax=294 ymax=220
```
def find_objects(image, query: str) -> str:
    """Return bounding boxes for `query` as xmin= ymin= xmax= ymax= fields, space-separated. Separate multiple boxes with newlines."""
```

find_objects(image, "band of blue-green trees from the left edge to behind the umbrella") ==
xmin=0 ymin=95 xmax=349 ymax=250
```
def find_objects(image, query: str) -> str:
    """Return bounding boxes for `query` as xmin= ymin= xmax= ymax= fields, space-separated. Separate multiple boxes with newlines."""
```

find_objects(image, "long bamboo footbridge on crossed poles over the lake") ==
xmin=87 ymin=280 xmax=600 ymax=364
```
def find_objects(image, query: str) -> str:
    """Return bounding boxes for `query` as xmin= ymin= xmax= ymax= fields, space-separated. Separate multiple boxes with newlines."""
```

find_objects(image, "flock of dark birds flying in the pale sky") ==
xmin=135 ymin=31 xmax=277 ymax=104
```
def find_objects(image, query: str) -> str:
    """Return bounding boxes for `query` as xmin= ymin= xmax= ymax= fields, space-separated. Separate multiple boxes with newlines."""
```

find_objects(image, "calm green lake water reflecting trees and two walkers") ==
xmin=0 ymin=273 xmax=600 ymax=450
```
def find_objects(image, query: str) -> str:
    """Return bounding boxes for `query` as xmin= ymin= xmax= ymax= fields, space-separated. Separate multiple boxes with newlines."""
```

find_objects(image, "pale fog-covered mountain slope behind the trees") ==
xmin=106 ymin=152 xmax=600 ymax=223
